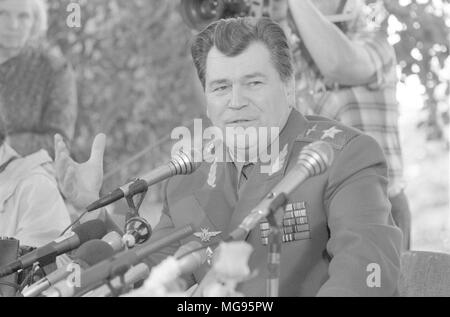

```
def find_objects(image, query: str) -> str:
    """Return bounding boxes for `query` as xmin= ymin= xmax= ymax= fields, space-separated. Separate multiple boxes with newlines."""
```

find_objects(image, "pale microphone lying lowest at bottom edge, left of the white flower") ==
xmin=82 ymin=263 xmax=150 ymax=297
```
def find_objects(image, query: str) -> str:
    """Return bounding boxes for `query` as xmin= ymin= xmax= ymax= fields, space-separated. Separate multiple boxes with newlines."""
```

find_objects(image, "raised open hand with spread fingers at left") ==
xmin=55 ymin=134 xmax=106 ymax=209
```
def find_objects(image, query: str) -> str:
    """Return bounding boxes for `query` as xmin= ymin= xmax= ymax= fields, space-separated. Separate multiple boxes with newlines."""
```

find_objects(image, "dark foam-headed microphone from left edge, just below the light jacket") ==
xmin=0 ymin=219 xmax=106 ymax=277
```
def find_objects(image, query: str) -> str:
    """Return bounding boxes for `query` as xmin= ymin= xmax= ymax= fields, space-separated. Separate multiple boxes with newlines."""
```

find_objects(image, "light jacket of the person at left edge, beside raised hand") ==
xmin=0 ymin=110 xmax=70 ymax=247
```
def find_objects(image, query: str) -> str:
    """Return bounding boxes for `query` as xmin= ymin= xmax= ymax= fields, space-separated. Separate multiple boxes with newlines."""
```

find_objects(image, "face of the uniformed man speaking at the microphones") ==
xmin=205 ymin=42 xmax=294 ymax=147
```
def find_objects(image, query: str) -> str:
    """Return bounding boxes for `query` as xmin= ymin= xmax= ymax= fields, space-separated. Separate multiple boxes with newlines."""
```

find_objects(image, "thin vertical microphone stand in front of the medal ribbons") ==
xmin=266 ymin=193 xmax=288 ymax=297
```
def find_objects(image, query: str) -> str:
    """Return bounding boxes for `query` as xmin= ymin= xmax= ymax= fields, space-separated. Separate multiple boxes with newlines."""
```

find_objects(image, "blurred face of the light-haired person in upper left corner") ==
xmin=0 ymin=0 xmax=34 ymax=49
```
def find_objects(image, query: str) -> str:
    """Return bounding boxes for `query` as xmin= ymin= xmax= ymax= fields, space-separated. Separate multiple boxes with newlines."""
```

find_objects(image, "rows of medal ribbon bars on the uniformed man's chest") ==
xmin=260 ymin=202 xmax=311 ymax=245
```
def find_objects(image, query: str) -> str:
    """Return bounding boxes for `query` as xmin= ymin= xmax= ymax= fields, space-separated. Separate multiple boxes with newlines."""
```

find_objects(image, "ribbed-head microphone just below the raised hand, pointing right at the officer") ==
xmin=86 ymin=151 xmax=201 ymax=212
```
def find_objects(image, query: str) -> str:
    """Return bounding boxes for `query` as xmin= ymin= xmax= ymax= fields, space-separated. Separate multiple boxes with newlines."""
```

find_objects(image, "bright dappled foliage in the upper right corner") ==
xmin=378 ymin=0 xmax=450 ymax=146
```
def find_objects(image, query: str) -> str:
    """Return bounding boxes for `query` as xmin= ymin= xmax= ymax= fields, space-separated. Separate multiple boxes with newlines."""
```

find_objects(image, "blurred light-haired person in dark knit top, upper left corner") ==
xmin=0 ymin=0 xmax=77 ymax=156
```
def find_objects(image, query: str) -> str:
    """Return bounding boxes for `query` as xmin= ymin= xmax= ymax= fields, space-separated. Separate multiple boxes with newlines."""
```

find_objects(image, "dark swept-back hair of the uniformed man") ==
xmin=191 ymin=17 xmax=294 ymax=88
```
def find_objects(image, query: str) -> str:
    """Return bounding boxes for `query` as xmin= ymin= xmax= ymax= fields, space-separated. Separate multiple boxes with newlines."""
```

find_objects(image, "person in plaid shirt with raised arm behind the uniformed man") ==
xmin=271 ymin=0 xmax=411 ymax=249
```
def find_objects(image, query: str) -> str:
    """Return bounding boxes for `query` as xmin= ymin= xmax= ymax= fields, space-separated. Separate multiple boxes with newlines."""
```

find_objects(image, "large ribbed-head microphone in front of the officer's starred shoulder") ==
xmin=225 ymin=141 xmax=334 ymax=241
